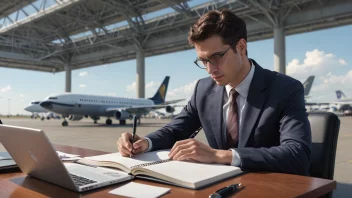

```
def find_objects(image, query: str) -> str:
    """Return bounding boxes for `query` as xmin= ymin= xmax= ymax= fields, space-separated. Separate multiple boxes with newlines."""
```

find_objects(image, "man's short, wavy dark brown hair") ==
xmin=188 ymin=9 xmax=247 ymax=52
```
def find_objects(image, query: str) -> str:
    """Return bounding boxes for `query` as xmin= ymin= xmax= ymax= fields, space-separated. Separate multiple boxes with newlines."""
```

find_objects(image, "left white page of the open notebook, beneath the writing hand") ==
xmin=85 ymin=150 xmax=169 ymax=167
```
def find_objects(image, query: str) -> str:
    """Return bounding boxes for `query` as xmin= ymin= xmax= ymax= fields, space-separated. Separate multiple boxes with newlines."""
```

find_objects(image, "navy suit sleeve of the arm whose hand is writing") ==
xmin=146 ymin=81 xmax=201 ymax=151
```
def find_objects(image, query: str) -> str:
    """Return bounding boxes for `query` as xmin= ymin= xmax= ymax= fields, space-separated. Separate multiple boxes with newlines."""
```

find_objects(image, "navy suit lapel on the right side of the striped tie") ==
xmin=238 ymin=60 xmax=268 ymax=148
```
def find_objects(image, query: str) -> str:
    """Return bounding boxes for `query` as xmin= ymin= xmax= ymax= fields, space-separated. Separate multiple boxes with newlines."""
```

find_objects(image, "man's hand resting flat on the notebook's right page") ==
xmin=169 ymin=138 xmax=232 ymax=164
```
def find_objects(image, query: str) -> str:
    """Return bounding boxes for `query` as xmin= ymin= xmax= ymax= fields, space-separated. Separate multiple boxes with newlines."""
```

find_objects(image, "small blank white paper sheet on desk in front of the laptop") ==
xmin=109 ymin=182 xmax=170 ymax=198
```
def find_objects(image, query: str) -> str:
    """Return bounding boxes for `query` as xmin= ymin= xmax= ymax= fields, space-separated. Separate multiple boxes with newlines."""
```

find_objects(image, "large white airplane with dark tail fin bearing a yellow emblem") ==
xmin=40 ymin=76 xmax=184 ymax=126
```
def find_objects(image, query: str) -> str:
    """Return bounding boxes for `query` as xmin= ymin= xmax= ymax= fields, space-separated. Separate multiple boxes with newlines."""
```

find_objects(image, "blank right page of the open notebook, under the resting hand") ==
xmin=140 ymin=161 xmax=242 ymax=188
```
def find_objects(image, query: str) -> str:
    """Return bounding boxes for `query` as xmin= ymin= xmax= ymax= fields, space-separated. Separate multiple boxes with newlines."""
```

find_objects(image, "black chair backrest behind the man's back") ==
xmin=308 ymin=112 xmax=340 ymax=179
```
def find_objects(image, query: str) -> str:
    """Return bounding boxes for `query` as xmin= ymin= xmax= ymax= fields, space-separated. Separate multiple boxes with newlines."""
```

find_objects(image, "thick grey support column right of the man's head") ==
xmin=274 ymin=25 xmax=286 ymax=74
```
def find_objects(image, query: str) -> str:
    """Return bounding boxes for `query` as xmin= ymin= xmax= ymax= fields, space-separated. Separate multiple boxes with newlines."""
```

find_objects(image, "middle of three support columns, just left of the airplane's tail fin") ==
xmin=136 ymin=49 xmax=145 ymax=98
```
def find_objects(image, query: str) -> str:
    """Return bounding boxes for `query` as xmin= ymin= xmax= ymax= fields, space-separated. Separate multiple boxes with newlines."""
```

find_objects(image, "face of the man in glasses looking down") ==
xmin=194 ymin=36 xmax=243 ymax=86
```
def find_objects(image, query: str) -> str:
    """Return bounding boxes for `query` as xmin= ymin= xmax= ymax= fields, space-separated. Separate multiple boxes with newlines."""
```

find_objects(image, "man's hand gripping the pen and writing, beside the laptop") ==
xmin=116 ymin=133 xmax=149 ymax=157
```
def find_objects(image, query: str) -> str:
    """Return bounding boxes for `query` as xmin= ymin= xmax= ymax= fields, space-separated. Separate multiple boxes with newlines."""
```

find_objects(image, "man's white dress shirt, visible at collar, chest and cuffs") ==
xmin=145 ymin=62 xmax=255 ymax=166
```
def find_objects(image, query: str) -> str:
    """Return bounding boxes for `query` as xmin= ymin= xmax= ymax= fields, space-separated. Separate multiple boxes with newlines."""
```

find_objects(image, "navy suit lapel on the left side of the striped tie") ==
xmin=208 ymin=86 xmax=225 ymax=149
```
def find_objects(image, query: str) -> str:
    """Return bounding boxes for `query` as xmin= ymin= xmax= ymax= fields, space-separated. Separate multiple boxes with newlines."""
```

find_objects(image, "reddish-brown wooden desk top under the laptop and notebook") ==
xmin=0 ymin=145 xmax=336 ymax=198
